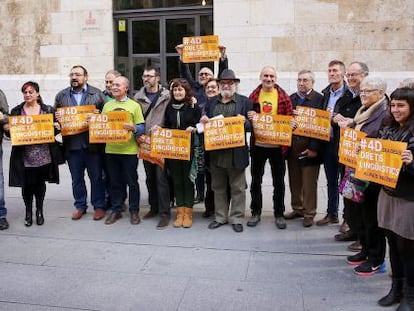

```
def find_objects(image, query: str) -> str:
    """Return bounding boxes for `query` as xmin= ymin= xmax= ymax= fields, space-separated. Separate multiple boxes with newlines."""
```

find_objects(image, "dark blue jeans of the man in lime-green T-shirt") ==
xmin=105 ymin=154 xmax=141 ymax=213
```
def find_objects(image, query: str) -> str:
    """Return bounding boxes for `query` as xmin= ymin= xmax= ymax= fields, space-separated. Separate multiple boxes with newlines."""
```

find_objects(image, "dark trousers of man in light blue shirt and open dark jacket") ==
xmin=323 ymin=141 xmax=339 ymax=216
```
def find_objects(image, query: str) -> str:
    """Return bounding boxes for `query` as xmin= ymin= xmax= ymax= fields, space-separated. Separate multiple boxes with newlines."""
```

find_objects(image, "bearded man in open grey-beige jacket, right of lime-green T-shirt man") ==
xmin=134 ymin=67 xmax=170 ymax=229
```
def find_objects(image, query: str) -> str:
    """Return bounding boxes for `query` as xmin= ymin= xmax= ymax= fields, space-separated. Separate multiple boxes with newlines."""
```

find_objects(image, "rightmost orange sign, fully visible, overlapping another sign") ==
xmin=355 ymin=138 xmax=407 ymax=188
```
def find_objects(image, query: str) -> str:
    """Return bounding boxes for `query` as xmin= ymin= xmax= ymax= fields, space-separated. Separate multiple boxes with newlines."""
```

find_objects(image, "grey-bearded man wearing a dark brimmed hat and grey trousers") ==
xmin=200 ymin=69 xmax=253 ymax=232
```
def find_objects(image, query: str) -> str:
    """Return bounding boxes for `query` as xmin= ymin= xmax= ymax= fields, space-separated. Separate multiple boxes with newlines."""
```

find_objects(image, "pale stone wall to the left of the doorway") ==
xmin=0 ymin=0 xmax=114 ymax=107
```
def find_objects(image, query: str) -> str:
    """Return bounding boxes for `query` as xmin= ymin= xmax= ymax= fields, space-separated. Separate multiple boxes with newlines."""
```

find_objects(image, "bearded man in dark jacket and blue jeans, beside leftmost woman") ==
xmin=54 ymin=65 xmax=105 ymax=220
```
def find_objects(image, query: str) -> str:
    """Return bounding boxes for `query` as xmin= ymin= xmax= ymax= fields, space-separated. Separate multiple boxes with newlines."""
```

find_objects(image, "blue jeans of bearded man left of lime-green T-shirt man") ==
xmin=68 ymin=149 xmax=105 ymax=211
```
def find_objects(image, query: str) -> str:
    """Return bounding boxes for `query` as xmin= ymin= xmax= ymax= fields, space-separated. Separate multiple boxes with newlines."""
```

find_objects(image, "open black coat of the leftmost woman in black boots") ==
xmin=9 ymin=103 xmax=63 ymax=187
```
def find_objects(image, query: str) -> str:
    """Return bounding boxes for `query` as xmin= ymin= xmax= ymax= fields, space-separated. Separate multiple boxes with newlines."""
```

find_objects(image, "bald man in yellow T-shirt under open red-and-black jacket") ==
xmin=247 ymin=66 xmax=292 ymax=229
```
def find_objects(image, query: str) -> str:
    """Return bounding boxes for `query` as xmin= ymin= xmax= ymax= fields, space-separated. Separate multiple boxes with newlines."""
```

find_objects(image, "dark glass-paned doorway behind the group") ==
xmin=114 ymin=7 xmax=214 ymax=94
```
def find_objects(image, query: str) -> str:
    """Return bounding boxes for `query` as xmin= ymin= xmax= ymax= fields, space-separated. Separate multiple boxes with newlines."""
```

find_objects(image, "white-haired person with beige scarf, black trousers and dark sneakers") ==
xmin=338 ymin=76 xmax=389 ymax=276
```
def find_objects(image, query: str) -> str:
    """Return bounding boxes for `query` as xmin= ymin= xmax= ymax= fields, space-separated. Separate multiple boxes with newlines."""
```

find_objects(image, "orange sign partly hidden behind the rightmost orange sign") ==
xmin=338 ymin=128 xmax=366 ymax=168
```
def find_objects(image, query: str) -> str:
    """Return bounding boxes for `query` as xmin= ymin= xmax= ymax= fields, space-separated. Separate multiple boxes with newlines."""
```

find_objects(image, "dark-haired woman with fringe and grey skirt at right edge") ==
xmin=378 ymin=88 xmax=414 ymax=311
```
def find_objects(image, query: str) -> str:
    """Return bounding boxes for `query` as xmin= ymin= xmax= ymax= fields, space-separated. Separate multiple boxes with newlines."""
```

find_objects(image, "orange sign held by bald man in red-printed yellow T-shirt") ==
xmin=252 ymin=113 xmax=292 ymax=146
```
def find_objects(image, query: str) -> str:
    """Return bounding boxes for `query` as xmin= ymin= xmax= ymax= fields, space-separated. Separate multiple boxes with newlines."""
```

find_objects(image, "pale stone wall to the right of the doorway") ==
xmin=214 ymin=0 xmax=414 ymax=93
